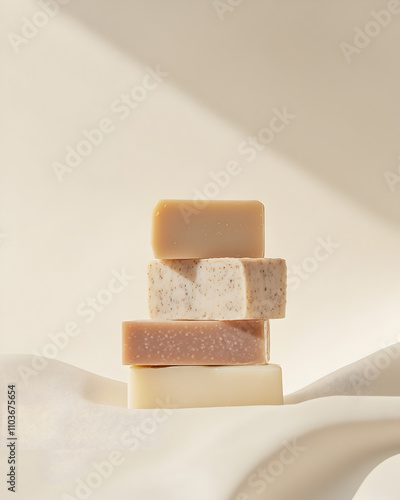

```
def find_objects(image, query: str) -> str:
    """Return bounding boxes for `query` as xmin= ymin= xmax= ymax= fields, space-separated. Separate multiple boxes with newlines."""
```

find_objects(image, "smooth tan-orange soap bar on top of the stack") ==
xmin=152 ymin=200 xmax=265 ymax=259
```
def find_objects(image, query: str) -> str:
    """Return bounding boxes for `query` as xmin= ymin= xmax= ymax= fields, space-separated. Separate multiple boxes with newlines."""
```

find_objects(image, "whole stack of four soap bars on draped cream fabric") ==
xmin=123 ymin=200 xmax=287 ymax=408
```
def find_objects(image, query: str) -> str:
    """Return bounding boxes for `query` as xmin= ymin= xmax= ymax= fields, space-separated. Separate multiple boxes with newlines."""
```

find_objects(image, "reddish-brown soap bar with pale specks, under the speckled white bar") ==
xmin=122 ymin=320 xmax=269 ymax=366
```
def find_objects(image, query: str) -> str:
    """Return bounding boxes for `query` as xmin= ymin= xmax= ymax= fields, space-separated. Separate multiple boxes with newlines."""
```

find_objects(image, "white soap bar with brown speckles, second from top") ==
xmin=148 ymin=258 xmax=287 ymax=320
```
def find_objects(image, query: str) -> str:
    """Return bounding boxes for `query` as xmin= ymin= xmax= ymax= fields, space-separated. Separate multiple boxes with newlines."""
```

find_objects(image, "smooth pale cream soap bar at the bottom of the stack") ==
xmin=128 ymin=364 xmax=283 ymax=409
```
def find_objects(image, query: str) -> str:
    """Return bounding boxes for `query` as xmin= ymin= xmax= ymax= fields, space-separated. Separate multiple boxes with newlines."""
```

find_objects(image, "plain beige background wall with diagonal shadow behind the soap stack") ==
xmin=0 ymin=0 xmax=400 ymax=498
